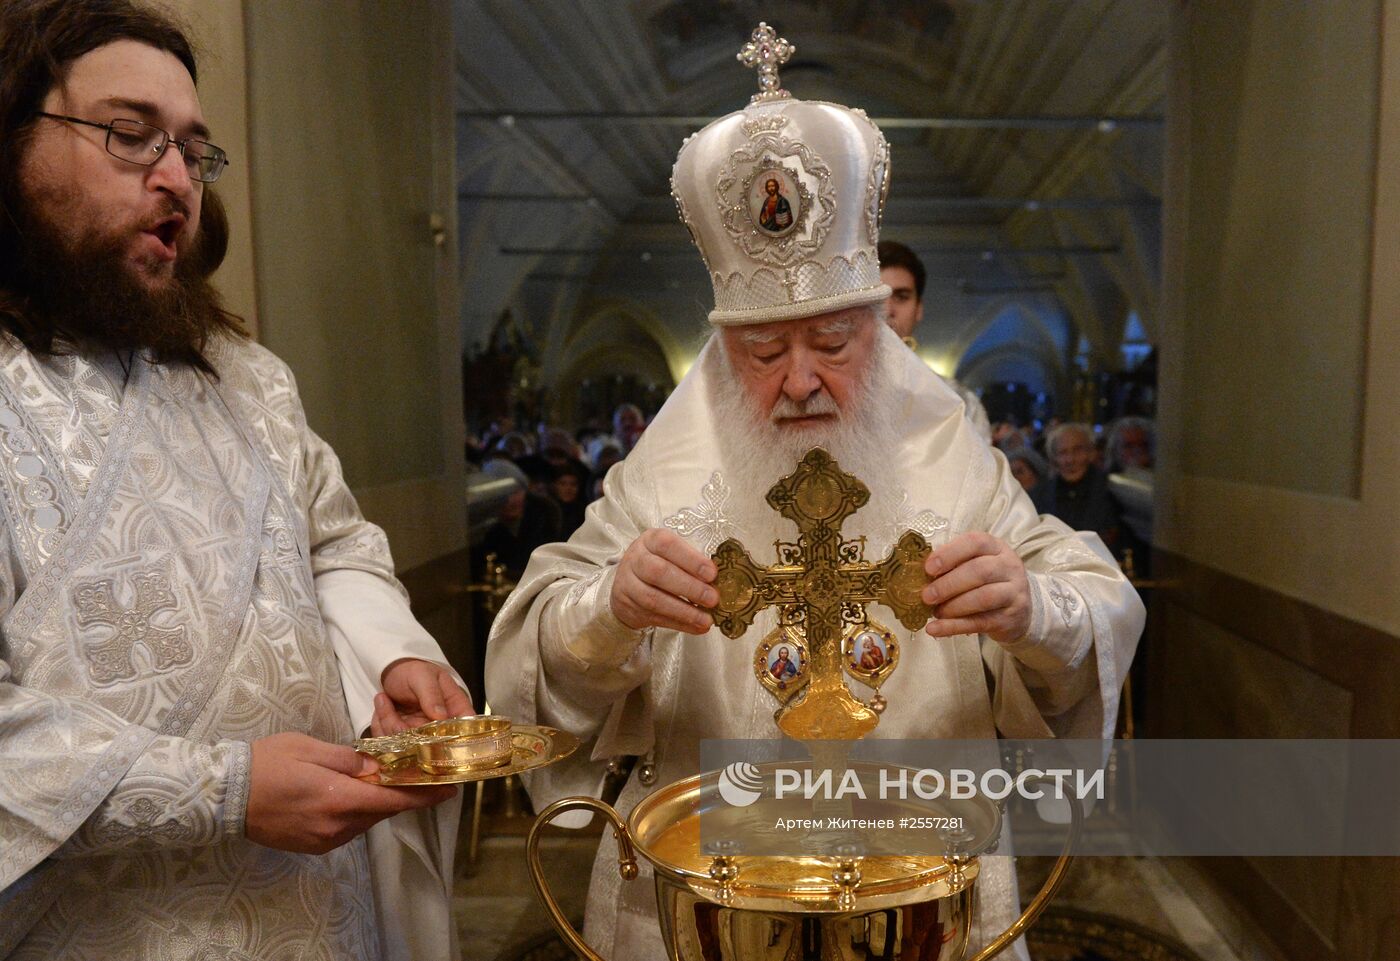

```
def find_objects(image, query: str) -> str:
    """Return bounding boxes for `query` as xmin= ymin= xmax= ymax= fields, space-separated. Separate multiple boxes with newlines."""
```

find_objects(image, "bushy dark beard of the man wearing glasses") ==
xmin=18 ymin=191 xmax=227 ymax=373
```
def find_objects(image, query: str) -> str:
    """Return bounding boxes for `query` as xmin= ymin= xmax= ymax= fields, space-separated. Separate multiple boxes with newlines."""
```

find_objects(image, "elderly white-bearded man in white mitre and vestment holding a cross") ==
xmin=486 ymin=20 xmax=1144 ymax=960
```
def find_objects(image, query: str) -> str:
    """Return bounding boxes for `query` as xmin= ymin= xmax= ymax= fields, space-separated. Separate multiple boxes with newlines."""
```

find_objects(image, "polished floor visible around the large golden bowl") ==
xmin=455 ymin=801 xmax=1278 ymax=961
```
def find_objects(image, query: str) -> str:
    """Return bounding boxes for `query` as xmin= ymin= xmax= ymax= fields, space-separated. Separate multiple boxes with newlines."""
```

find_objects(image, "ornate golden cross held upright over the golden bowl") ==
xmin=713 ymin=447 xmax=932 ymax=740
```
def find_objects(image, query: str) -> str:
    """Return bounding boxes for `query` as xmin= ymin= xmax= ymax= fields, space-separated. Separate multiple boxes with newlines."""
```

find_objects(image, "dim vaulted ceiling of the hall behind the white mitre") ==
xmin=454 ymin=0 xmax=1168 ymax=406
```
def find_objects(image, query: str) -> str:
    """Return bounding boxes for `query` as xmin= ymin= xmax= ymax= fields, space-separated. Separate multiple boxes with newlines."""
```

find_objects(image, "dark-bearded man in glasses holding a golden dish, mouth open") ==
xmin=0 ymin=0 xmax=470 ymax=960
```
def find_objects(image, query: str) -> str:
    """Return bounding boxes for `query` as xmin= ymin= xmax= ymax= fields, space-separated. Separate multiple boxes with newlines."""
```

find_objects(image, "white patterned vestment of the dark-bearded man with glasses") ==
xmin=0 ymin=333 xmax=456 ymax=961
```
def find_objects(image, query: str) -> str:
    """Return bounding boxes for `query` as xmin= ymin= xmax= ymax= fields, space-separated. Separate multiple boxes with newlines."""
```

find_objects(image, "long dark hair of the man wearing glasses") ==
xmin=0 ymin=0 xmax=245 ymax=373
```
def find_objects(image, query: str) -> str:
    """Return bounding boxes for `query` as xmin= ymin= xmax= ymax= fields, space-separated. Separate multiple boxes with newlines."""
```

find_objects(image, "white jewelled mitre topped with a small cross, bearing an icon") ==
xmin=671 ymin=24 xmax=890 ymax=326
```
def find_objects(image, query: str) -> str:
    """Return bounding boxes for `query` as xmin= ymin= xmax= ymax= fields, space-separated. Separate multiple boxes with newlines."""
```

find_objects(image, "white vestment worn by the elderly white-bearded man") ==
xmin=486 ymin=326 xmax=1145 ymax=961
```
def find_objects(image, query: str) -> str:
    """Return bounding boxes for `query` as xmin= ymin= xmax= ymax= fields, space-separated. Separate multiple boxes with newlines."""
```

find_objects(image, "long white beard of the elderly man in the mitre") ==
xmin=707 ymin=324 xmax=904 ymax=565
